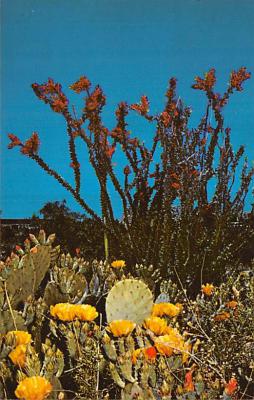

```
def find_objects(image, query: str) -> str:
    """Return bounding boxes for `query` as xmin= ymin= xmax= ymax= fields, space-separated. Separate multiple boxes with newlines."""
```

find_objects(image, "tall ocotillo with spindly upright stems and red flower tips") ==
xmin=9 ymin=67 xmax=254 ymax=286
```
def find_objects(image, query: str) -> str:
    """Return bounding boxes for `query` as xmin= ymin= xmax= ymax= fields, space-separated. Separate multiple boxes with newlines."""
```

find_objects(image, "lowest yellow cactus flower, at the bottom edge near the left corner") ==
xmin=15 ymin=376 xmax=53 ymax=400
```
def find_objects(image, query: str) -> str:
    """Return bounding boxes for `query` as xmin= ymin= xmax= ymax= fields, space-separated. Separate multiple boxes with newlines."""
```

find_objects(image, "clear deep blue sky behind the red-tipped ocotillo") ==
xmin=0 ymin=0 xmax=254 ymax=218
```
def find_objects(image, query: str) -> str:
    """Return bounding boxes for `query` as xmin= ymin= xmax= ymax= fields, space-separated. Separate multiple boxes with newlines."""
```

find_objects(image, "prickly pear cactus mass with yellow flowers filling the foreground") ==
xmin=0 ymin=231 xmax=254 ymax=400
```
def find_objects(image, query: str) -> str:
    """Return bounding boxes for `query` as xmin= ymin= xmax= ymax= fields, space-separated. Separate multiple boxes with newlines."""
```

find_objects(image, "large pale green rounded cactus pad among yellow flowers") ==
xmin=106 ymin=279 xmax=153 ymax=324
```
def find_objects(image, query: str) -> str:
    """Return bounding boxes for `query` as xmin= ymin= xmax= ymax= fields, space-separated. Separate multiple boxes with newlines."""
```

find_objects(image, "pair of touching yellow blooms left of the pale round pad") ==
xmin=50 ymin=303 xmax=99 ymax=321
